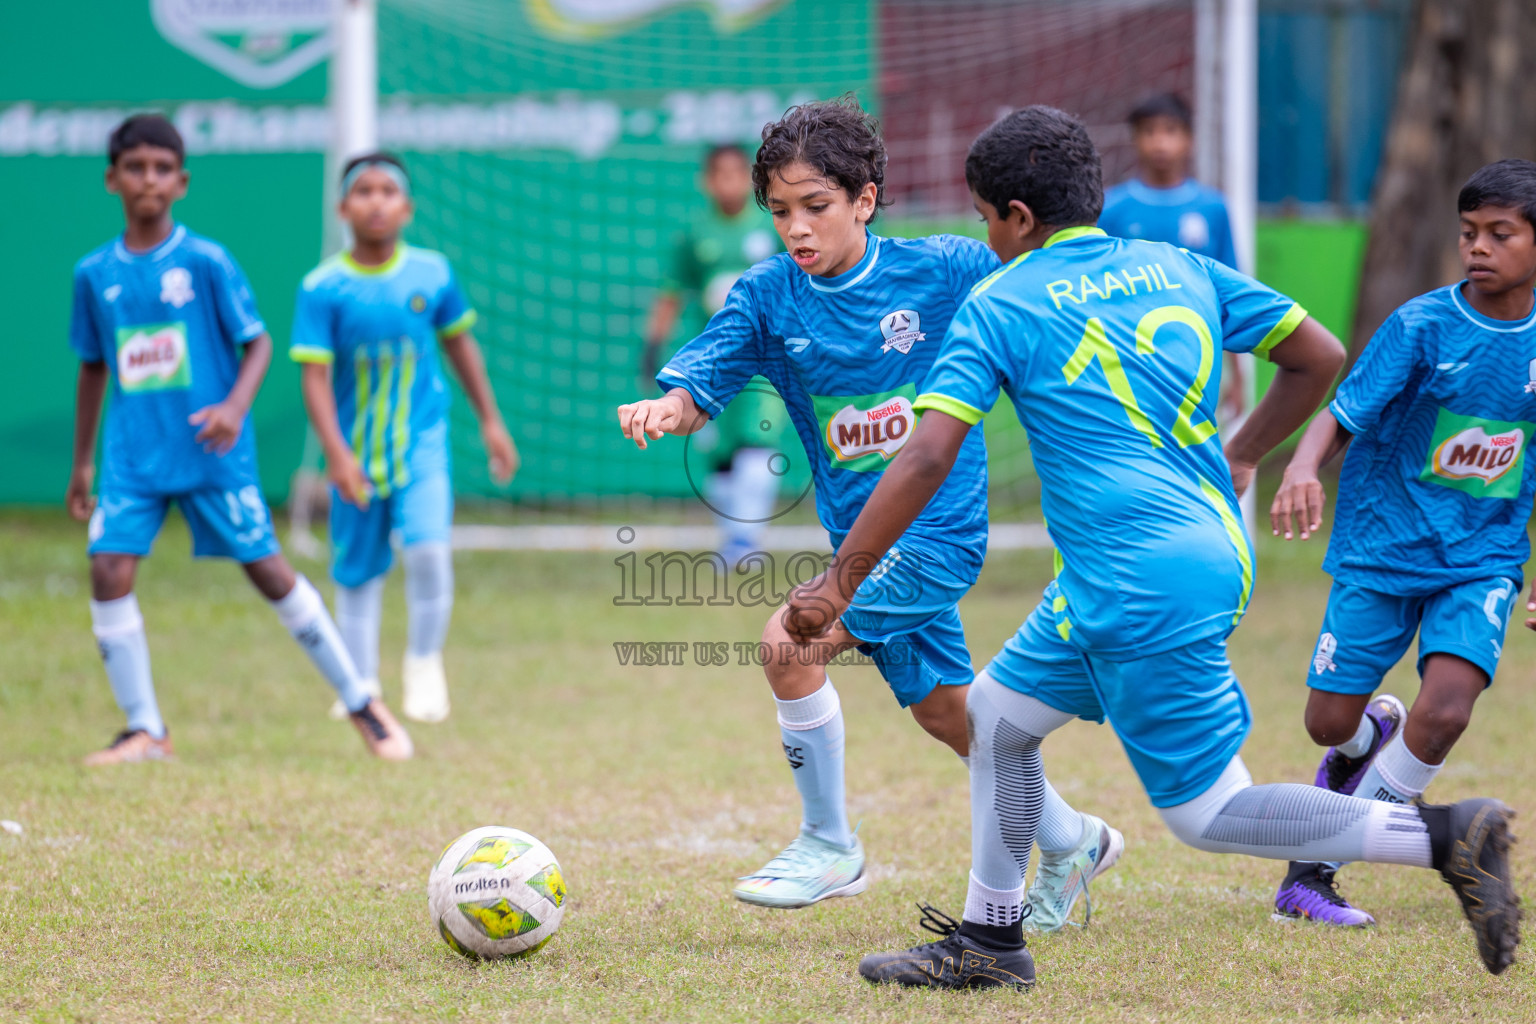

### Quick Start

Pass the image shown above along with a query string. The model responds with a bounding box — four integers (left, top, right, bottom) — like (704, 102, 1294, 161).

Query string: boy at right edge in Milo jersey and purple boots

(1272, 160, 1536, 926)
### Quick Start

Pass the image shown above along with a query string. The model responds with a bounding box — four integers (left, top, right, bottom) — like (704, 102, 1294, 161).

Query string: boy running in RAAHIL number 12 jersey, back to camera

(785, 107, 1519, 989)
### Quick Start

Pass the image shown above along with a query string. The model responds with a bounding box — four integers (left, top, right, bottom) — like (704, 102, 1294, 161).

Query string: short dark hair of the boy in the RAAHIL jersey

(965, 106, 1104, 227)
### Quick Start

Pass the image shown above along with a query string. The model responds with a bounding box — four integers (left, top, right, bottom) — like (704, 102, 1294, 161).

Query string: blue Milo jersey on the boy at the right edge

(1322, 284, 1536, 594)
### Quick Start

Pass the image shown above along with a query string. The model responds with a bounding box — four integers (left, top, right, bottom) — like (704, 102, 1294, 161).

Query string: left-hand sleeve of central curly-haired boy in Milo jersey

(656, 275, 766, 419)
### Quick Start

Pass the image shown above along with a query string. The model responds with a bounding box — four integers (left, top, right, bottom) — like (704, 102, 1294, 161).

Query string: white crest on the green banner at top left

(149, 0, 335, 89)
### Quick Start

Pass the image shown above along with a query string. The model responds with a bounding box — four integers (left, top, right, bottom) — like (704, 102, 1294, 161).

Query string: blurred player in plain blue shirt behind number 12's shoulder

(1098, 92, 1247, 421)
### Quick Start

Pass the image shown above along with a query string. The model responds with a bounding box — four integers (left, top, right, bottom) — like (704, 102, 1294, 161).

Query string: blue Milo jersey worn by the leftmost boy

(69, 224, 266, 494)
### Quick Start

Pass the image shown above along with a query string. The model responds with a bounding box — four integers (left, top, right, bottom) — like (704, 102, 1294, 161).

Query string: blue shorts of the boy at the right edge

(1307, 576, 1521, 694)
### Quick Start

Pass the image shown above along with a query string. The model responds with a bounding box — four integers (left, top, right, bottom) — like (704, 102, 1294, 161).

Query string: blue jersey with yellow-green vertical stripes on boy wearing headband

(289, 243, 475, 497)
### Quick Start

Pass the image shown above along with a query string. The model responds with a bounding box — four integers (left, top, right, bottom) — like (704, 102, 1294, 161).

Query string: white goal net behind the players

(295, 0, 1213, 552)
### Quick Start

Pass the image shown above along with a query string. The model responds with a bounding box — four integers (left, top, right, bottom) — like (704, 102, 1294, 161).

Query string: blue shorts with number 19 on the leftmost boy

(88, 484, 283, 565)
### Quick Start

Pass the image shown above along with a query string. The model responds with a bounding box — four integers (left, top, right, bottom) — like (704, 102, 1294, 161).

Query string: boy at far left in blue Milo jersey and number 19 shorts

(65, 115, 412, 765)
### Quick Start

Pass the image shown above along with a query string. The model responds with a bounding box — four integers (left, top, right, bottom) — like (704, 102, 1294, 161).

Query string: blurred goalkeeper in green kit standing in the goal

(641, 144, 788, 568)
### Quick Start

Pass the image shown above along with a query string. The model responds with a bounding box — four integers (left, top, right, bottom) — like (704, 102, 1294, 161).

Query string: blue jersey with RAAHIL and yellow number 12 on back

(917, 227, 1306, 660)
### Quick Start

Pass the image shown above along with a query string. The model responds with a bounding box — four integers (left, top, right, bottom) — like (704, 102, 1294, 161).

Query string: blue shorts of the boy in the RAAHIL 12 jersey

(986, 583, 1253, 808)
